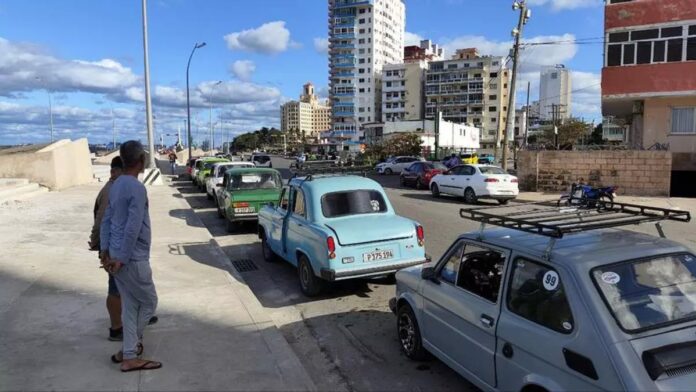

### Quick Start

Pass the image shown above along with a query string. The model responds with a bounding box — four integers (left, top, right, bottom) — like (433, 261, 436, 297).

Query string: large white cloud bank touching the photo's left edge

(0, 38, 140, 96)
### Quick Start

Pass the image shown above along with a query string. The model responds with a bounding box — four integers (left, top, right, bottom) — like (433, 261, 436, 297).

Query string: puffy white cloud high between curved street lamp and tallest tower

(224, 21, 296, 54)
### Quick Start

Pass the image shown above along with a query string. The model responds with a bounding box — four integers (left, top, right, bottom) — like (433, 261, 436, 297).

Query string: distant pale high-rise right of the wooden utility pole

(539, 64, 571, 120)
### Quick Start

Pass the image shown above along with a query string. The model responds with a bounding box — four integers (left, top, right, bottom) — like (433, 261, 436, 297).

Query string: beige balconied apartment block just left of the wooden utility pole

(425, 48, 512, 150)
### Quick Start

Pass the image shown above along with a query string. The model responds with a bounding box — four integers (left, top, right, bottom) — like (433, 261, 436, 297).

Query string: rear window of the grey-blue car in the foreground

(592, 254, 696, 331)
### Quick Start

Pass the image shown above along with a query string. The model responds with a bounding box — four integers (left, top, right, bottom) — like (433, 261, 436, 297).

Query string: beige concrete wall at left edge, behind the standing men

(0, 139, 93, 190)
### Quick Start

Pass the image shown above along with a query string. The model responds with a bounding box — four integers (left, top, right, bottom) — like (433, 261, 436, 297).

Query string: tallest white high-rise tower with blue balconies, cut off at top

(329, 0, 406, 140)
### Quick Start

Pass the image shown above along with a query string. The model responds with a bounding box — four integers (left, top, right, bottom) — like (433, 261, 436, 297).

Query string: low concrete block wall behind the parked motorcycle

(517, 151, 672, 196)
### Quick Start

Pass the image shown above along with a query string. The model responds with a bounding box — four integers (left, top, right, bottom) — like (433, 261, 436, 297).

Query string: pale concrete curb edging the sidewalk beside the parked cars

(166, 181, 317, 391)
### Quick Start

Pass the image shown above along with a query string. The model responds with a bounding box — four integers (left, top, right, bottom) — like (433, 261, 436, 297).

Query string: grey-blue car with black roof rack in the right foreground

(389, 202, 696, 391)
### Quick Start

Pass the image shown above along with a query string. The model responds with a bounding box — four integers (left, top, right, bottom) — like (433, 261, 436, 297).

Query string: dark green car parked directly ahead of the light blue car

(215, 168, 283, 233)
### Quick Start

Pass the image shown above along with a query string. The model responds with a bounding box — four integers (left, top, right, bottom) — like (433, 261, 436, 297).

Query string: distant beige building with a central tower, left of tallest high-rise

(280, 83, 331, 138)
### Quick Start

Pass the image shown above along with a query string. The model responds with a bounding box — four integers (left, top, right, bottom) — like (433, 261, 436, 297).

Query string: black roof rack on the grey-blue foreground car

(459, 201, 691, 239)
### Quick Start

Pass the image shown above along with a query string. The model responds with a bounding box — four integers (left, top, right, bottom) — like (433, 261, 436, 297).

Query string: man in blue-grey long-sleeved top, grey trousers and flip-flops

(100, 140, 162, 372)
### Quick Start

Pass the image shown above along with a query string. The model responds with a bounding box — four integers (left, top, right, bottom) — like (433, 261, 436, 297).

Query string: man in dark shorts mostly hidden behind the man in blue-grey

(89, 157, 123, 341)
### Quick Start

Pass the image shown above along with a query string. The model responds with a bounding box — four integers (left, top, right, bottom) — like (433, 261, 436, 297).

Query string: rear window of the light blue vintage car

(321, 189, 387, 218)
